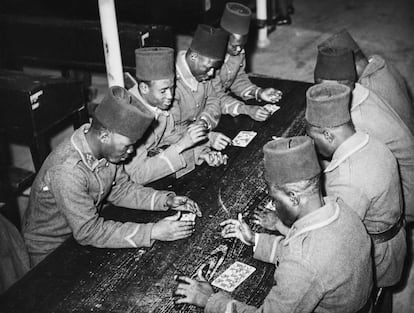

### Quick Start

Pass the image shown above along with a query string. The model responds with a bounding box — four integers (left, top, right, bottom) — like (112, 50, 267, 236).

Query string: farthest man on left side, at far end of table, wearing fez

(213, 2, 282, 121)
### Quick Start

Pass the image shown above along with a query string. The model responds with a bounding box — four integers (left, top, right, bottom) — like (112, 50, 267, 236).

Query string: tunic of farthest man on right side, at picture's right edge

(358, 55, 414, 134)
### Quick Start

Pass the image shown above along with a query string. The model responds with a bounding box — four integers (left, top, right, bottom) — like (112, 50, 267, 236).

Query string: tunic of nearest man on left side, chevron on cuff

(23, 124, 174, 266)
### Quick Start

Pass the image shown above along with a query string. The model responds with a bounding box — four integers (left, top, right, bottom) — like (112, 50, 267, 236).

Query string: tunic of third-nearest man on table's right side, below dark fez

(351, 83, 414, 221)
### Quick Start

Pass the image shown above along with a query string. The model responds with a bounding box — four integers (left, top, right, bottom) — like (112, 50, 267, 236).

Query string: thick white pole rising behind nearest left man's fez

(98, 0, 124, 87)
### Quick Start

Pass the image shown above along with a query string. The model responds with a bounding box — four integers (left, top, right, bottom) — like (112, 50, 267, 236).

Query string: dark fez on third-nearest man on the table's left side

(190, 24, 228, 60)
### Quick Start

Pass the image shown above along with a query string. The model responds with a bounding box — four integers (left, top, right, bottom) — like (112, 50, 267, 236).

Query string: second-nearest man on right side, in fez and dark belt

(306, 83, 406, 294)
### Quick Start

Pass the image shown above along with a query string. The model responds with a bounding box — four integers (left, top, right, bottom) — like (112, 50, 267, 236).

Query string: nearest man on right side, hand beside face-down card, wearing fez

(175, 136, 372, 313)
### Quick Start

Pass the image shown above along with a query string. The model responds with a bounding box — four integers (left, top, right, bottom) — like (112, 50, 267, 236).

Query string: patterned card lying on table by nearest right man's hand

(212, 261, 256, 292)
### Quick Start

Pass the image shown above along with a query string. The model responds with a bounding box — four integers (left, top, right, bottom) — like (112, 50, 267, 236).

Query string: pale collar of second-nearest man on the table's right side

(324, 132, 369, 173)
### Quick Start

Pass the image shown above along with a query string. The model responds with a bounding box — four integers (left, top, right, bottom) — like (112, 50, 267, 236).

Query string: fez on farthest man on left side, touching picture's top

(220, 2, 252, 35)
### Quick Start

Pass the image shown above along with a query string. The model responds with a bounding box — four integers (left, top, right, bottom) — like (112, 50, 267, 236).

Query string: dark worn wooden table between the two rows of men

(0, 76, 310, 313)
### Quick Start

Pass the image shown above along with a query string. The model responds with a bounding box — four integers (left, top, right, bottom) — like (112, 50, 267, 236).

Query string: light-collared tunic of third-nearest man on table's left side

(171, 51, 221, 131)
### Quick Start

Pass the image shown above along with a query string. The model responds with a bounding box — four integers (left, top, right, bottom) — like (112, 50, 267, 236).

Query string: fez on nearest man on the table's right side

(263, 136, 321, 185)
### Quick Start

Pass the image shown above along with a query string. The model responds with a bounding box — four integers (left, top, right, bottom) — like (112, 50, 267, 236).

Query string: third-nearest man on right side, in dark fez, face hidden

(314, 47, 414, 222)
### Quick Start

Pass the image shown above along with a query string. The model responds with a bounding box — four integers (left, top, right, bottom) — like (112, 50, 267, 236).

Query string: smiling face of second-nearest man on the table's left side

(145, 78, 175, 110)
